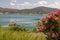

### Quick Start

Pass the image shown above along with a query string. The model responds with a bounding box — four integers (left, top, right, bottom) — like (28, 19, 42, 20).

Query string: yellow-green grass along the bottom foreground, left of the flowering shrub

(0, 29, 46, 40)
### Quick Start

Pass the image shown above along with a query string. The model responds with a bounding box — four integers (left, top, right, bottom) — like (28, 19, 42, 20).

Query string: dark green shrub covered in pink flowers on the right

(40, 10, 60, 40)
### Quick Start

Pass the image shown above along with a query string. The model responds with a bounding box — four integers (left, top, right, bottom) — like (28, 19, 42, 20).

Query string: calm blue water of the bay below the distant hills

(0, 14, 45, 28)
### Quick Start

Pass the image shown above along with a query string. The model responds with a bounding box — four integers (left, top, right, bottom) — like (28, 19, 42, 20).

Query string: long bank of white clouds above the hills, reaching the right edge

(10, 1, 60, 9)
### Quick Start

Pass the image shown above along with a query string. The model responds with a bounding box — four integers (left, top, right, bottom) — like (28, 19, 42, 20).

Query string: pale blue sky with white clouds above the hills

(0, 0, 60, 9)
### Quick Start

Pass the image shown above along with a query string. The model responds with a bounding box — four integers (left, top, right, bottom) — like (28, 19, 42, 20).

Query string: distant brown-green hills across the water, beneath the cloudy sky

(0, 6, 57, 14)
